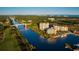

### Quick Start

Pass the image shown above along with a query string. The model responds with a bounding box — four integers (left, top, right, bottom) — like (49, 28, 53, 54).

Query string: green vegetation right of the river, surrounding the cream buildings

(16, 15, 79, 39)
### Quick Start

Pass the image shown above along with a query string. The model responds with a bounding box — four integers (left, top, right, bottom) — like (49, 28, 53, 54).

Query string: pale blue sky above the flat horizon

(0, 7, 79, 15)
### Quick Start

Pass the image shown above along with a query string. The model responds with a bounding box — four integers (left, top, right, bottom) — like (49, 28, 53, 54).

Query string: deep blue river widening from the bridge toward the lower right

(11, 18, 79, 51)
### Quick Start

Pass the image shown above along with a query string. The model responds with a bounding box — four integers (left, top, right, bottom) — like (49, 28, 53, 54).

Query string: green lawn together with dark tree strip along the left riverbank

(0, 27, 34, 51)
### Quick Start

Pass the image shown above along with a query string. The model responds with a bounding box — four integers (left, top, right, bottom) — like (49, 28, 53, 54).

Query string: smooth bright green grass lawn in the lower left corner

(0, 28, 21, 51)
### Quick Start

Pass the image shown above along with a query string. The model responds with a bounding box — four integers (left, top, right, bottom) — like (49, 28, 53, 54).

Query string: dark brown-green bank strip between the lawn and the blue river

(15, 28, 35, 51)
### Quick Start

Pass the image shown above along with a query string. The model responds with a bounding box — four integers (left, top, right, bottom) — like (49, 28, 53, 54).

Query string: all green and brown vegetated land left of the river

(0, 16, 35, 51)
